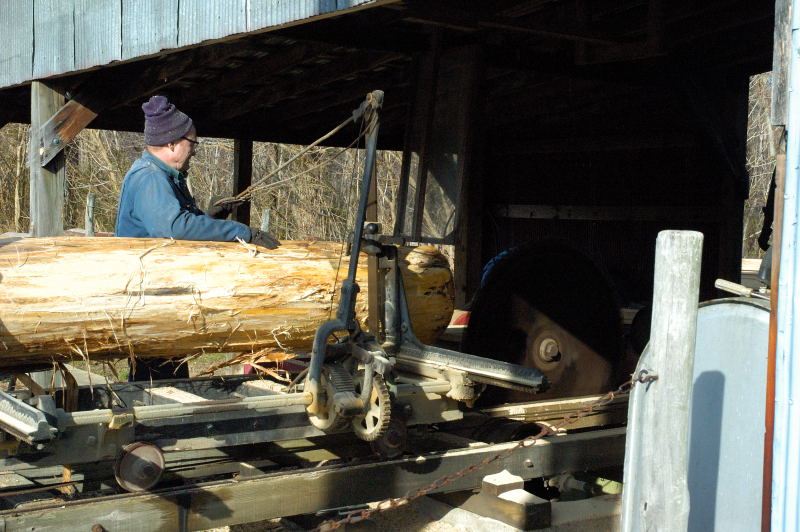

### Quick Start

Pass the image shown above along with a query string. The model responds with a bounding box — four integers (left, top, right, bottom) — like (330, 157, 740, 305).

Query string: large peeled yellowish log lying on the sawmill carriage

(0, 237, 453, 368)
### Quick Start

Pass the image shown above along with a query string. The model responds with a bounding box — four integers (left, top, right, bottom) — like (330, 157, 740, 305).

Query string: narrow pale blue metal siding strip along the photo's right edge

(772, 1, 800, 531)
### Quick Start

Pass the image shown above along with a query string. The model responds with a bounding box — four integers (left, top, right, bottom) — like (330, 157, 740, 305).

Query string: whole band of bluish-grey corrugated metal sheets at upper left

(0, 0, 384, 88)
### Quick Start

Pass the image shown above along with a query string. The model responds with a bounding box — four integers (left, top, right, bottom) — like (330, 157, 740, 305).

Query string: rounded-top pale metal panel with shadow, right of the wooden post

(688, 298, 769, 532)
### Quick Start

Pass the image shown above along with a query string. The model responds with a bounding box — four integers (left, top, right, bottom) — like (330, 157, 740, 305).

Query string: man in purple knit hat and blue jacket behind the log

(115, 96, 280, 380)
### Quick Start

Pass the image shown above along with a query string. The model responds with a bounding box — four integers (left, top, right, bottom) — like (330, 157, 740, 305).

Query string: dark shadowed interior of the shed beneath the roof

(0, 0, 775, 305)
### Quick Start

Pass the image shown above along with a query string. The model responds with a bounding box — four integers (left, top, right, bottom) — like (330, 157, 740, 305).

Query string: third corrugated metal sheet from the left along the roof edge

(74, 0, 122, 70)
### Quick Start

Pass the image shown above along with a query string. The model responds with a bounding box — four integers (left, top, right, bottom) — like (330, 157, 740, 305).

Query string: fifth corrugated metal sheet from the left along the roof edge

(178, 0, 247, 46)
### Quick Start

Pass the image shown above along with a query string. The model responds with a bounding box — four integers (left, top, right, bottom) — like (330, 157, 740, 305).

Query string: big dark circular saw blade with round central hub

(462, 242, 622, 404)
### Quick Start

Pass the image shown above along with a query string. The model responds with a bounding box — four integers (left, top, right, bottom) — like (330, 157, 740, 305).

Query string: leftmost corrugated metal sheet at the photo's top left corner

(0, 2, 33, 87)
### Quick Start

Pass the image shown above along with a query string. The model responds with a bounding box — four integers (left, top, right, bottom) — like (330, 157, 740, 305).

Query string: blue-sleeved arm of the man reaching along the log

(134, 174, 250, 242)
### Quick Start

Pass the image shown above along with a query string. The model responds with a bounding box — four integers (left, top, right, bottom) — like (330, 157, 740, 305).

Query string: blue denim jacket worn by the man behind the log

(116, 150, 250, 241)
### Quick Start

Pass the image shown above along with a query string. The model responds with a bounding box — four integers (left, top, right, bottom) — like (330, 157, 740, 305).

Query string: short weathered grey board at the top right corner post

(772, 0, 792, 126)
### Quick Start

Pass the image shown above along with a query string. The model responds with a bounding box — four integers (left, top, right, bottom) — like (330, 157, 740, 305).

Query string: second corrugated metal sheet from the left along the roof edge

(33, 0, 75, 78)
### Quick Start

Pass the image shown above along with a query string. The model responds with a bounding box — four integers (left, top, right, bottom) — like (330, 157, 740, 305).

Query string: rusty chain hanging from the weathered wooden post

(312, 369, 658, 532)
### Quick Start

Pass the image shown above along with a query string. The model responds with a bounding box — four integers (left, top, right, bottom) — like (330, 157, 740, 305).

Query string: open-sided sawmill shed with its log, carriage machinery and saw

(0, 0, 800, 531)
